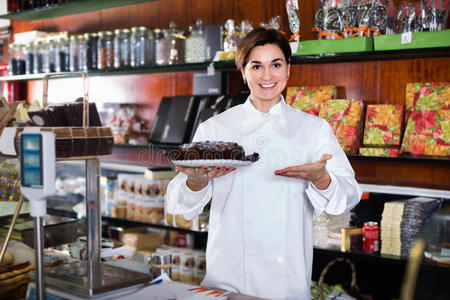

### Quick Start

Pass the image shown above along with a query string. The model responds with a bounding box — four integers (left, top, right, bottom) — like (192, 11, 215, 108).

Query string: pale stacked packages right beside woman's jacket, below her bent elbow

(314, 213, 350, 248)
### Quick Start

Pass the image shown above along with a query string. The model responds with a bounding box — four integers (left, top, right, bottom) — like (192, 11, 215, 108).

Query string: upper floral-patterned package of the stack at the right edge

(405, 82, 450, 120)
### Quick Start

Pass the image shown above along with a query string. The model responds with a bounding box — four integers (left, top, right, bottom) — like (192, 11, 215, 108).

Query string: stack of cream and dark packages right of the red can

(381, 197, 441, 256)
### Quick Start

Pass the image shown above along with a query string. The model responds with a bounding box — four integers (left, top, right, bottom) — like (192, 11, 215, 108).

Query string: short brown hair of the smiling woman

(235, 28, 292, 70)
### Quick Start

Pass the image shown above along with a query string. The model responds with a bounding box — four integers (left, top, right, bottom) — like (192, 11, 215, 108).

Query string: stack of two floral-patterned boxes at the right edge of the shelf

(401, 82, 450, 156)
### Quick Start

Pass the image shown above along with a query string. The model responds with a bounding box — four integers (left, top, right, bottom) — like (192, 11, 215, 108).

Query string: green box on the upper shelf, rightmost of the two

(373, 29, 450, 51)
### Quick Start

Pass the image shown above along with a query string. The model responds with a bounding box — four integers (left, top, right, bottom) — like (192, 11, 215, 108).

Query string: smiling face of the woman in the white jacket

(242, 44, 290, 105)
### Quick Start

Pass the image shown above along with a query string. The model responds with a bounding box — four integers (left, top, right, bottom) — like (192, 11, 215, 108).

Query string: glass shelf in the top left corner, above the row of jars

(0, 0, 155, 21)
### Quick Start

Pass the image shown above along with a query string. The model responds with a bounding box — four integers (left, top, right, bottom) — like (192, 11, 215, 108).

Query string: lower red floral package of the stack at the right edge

(401, 110, 450, 156)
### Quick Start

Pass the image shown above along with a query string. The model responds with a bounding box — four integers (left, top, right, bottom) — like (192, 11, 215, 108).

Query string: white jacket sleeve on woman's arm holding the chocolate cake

(166, 124, 213, 220)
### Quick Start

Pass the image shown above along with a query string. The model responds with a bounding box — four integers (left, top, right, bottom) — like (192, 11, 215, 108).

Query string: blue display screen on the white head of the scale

(20, 134, 42, 187)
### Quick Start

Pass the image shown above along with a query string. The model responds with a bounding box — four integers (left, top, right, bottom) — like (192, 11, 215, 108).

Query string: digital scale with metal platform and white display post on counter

(19, 127, 152, 300)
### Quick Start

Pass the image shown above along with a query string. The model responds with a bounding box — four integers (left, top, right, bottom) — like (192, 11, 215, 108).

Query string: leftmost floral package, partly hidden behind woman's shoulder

(286, 85, 337, 116)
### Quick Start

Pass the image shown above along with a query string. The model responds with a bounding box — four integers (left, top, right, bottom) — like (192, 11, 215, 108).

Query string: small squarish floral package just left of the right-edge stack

(363, 104, 403, 147)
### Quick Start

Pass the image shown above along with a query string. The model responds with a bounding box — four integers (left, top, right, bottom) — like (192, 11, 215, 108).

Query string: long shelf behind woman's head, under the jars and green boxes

(0, 47, 450, 81)
